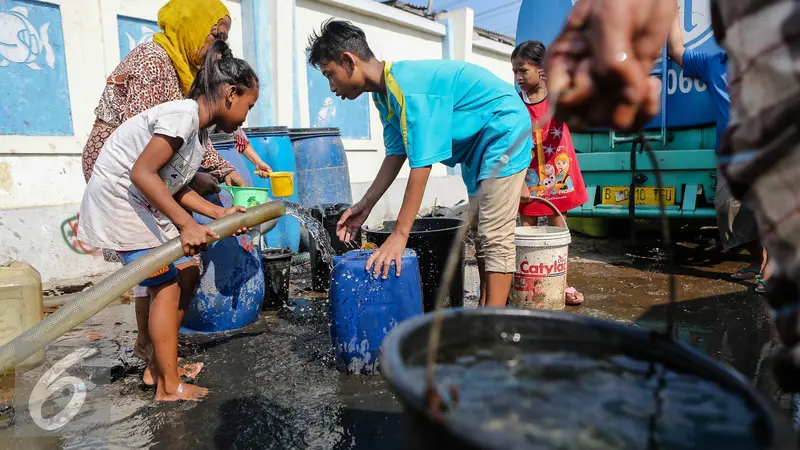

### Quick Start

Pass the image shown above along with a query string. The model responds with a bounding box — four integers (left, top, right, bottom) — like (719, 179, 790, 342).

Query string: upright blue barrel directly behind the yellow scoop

(244, 127, 300, 253)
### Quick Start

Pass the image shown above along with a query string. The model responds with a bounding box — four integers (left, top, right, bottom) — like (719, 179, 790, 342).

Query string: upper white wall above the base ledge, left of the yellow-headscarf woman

(0, 0, 242, 210)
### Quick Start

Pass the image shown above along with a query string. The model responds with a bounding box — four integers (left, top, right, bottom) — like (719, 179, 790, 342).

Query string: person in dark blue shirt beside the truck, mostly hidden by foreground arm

(667, 10, 769, 293)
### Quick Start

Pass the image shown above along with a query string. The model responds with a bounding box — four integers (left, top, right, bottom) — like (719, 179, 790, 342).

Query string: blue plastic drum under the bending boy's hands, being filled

(329, 250, 422, 375)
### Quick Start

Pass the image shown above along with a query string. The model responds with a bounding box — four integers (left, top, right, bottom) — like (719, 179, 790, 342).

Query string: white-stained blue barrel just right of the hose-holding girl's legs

(181, 191, 264, 333)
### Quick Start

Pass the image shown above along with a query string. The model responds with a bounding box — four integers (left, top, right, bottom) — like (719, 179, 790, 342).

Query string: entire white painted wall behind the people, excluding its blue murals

(0, 0, 512, 281)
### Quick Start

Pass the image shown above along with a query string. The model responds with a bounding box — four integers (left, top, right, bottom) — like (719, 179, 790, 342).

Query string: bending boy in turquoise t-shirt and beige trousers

(308, 20, 533, 307)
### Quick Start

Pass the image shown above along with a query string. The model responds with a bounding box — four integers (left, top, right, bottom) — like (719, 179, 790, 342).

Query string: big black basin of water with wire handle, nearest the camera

(381, 308, 796, 450)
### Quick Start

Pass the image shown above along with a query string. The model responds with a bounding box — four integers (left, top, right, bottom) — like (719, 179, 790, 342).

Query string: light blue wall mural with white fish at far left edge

(0, 0, 74, 136)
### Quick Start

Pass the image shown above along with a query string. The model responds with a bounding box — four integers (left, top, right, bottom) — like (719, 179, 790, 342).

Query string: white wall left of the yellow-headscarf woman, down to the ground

(0, 0, 242, 282)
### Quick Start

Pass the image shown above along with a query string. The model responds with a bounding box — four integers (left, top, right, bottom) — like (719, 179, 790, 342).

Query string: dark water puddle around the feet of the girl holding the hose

(0, 299, 404, 449)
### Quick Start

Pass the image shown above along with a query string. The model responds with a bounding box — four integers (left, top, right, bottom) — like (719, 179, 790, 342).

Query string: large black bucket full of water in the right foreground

(381, 308, 795, 450)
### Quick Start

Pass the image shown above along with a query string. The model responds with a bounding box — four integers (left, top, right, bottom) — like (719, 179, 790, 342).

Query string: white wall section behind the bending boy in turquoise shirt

(295, 0, 513, 217)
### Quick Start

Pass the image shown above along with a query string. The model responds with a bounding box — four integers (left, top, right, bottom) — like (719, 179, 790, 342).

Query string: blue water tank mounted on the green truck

(517, 0, 722, 128)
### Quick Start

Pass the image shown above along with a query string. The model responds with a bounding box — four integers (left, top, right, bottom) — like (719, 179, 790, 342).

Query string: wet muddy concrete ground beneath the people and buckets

(0, 223, 785, 450)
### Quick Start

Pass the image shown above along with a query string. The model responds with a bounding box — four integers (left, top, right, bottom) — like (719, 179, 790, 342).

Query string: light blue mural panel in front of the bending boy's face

(307, 57, 370, 139)
